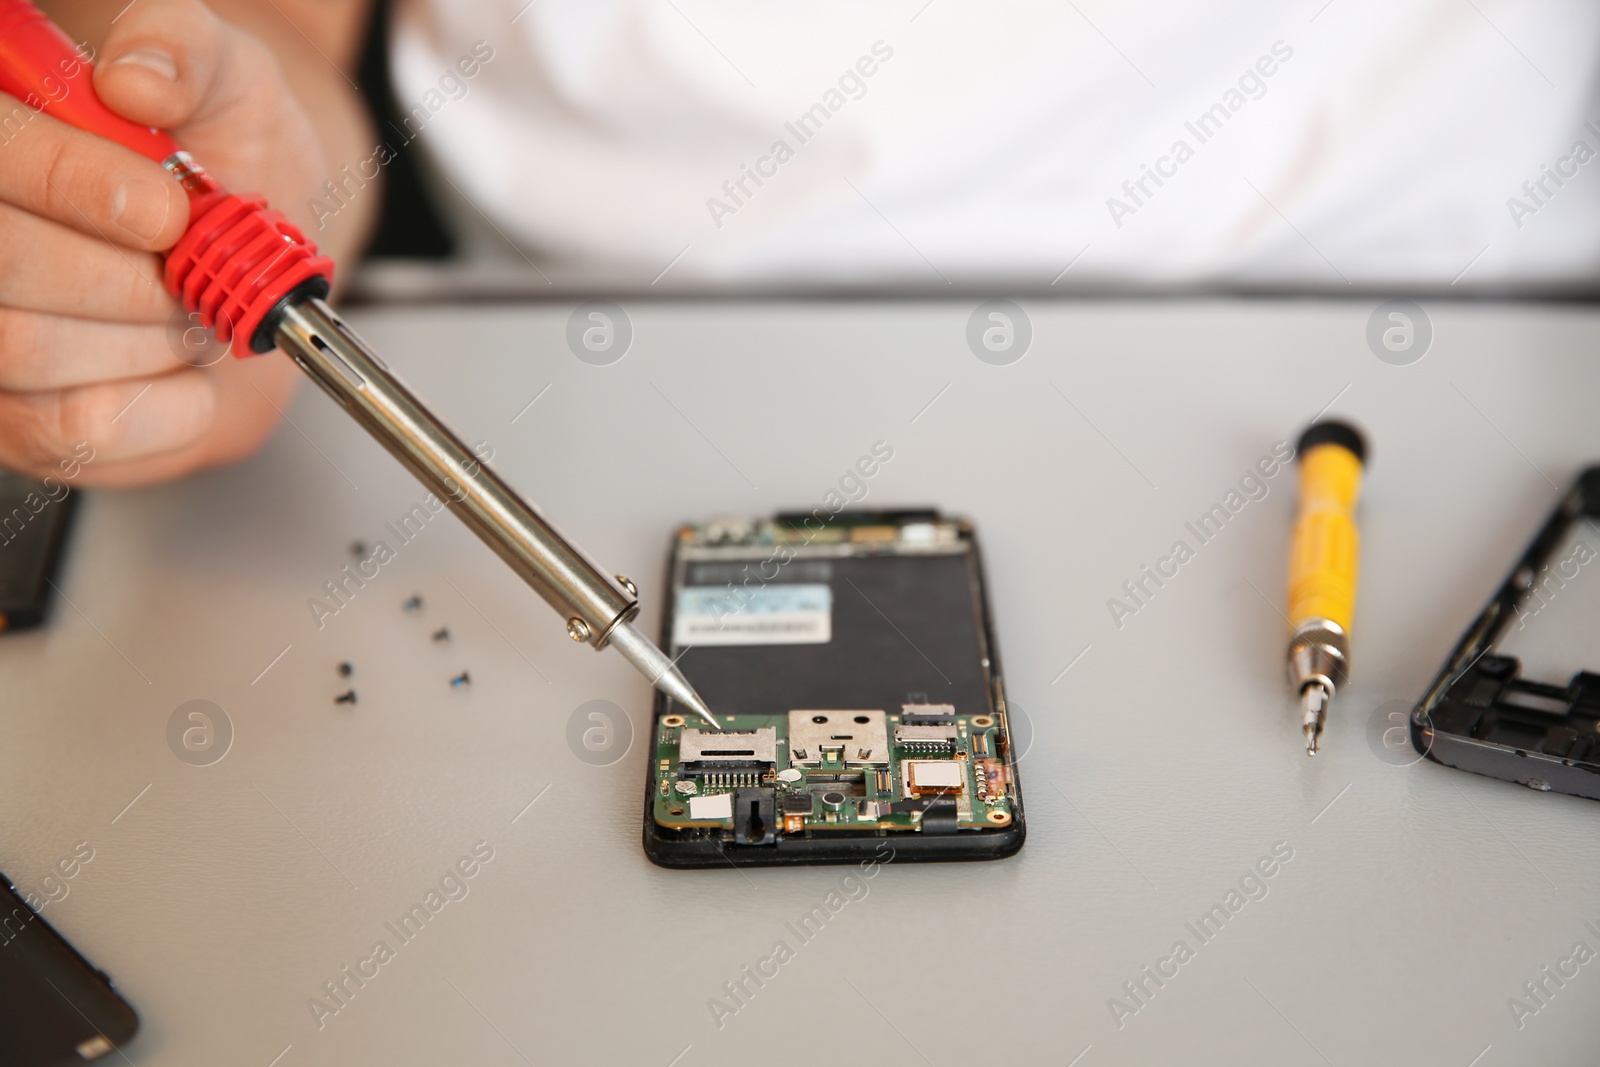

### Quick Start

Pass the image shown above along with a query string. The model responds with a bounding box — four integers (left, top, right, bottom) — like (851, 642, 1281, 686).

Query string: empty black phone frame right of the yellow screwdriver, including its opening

(1411, 467, 1600, 800)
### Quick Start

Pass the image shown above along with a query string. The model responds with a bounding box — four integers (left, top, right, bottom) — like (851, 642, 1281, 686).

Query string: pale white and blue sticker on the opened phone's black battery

(672, 582, 834, 646)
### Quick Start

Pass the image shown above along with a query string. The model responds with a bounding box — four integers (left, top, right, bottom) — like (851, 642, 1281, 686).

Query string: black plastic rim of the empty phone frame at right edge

(1411, 467, 1600, 800)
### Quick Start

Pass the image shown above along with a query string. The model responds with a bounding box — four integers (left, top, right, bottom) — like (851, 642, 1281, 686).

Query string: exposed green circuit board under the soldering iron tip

(653, 704, 1014, 845)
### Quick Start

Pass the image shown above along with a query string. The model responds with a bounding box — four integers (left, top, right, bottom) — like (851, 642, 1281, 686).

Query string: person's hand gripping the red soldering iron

(0, 0, 345, 486)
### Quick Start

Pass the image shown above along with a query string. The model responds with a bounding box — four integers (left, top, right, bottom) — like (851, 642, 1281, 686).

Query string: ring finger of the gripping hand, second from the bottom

(0, 307, 212, 392)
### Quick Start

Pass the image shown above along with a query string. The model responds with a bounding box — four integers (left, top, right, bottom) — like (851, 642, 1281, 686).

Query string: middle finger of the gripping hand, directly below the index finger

(0, 203, 176, 323)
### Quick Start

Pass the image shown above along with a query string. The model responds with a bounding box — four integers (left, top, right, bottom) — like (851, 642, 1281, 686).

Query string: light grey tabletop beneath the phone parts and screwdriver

(0, 301, 1600, 1067)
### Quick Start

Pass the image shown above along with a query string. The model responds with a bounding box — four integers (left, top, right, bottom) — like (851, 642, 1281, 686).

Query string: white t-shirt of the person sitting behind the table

(386, 0, 1600, 291)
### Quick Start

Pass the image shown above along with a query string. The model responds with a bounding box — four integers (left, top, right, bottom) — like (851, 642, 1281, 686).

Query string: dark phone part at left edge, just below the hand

(0, 470, 78, 633)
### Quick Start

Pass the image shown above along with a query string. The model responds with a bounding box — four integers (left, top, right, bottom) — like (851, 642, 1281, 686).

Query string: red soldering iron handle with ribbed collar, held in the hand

(0, 0, 333, 355)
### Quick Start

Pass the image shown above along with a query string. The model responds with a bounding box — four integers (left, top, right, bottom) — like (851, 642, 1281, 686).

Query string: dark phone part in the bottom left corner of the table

(0, 875, 139, 1067)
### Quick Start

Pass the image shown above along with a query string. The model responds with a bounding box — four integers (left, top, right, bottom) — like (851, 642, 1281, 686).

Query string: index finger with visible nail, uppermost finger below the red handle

(0, 93, 189, 250)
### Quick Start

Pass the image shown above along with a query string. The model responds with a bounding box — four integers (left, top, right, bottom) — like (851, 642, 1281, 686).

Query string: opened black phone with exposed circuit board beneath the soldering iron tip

(645, 509, 1024, 867)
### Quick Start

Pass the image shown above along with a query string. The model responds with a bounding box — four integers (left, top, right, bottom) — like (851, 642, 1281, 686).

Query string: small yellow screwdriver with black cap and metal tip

(1288, 421, 1366, 755)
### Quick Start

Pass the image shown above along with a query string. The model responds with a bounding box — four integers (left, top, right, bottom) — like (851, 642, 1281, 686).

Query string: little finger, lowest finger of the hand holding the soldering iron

(0, 368, 216, 472)
